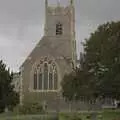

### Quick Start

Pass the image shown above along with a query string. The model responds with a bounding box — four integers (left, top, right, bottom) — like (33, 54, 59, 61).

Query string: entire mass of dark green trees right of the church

(62, 22, 120, 105)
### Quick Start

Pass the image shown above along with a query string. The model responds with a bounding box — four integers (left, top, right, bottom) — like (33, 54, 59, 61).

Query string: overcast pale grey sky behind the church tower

(0, 0, 120, 71)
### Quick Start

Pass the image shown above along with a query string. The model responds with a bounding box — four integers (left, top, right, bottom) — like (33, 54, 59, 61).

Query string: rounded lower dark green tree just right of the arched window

(62, 68, 95, 101)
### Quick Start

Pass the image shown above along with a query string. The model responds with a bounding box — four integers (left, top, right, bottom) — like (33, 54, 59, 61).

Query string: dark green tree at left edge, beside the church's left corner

(0, 60, 19, 112)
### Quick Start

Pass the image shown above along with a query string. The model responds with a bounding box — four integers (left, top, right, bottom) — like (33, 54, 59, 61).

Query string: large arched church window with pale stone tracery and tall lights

(33, 59, 58, 91)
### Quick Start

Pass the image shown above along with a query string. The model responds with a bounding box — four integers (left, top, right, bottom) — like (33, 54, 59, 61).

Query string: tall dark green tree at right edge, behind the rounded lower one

(84, 22, 120, 99)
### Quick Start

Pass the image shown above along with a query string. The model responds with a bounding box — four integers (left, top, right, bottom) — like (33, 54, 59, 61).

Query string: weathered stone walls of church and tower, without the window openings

(20, 0, 76, 110)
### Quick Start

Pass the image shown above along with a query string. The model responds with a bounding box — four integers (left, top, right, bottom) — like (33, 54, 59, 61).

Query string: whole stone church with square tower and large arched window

(20, 0, 77, 110)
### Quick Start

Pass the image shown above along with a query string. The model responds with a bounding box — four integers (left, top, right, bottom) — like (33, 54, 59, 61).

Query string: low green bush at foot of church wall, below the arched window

(18, 103, 45, 114)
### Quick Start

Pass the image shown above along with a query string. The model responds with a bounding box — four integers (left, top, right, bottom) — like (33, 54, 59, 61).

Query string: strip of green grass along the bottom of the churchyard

(0, 110, 120, 120)
